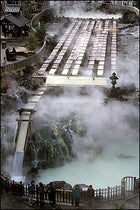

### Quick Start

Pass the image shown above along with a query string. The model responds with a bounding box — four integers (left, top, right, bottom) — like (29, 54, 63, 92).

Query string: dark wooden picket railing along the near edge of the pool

(0, 175, 139, 204)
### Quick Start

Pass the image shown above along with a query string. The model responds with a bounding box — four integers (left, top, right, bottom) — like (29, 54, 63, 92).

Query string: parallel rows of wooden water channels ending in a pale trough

(33, 19, 117, 86)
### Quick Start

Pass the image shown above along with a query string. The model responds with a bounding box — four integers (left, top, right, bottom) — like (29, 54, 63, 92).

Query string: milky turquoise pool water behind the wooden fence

(35, 139, 139, 189)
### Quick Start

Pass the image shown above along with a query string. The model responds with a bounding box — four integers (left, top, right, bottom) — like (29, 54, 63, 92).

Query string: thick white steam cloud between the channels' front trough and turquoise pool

(35, 88, 138, 147)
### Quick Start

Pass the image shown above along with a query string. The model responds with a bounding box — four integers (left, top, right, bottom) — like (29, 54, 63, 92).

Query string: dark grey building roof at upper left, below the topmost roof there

(4, 14, 30, 27)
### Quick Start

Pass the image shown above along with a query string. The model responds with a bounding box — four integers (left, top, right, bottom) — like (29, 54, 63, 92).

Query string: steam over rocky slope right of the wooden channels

(117, 26, 139, 88)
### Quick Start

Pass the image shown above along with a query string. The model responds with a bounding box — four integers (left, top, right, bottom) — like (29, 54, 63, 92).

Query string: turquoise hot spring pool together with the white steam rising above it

(23, 87, 139, 189)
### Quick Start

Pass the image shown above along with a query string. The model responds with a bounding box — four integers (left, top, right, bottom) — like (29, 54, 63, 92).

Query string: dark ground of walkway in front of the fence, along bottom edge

(1, 190, 139, 210)
